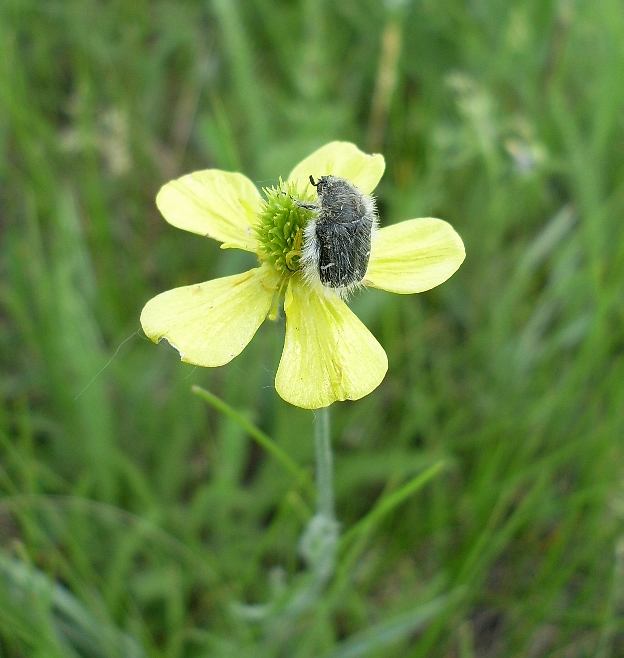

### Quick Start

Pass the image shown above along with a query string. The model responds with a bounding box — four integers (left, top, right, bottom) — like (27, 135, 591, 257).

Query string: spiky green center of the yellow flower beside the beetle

(255, 178, 314, 275)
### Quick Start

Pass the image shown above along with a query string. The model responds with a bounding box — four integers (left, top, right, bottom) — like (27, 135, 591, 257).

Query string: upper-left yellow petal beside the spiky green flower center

(156, 169, 260, 251)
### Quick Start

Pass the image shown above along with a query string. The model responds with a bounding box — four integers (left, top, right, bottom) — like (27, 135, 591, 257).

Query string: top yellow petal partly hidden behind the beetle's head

(288, 142, 386, 194)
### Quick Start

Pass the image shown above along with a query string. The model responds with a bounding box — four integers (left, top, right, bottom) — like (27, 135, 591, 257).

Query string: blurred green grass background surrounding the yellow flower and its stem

(0, 0, 624, 658)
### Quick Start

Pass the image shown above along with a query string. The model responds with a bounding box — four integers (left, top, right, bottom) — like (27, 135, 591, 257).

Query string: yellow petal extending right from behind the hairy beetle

(363, 217, 466, 293)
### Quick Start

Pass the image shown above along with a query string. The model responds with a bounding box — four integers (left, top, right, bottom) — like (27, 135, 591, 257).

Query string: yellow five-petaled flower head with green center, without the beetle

(141, 142, 465, 409)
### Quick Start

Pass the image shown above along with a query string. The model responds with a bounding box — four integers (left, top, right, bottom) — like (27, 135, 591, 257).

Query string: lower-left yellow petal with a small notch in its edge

(141, 267, 277, 367)
